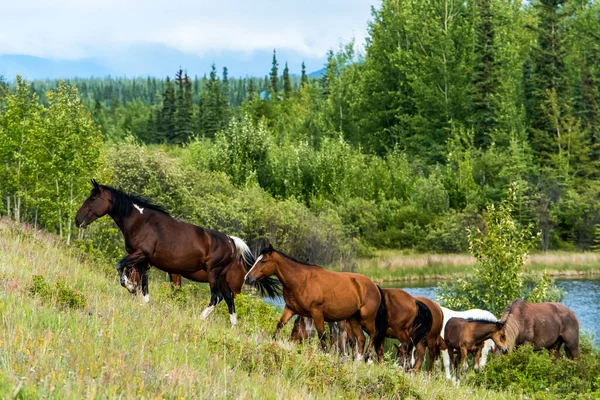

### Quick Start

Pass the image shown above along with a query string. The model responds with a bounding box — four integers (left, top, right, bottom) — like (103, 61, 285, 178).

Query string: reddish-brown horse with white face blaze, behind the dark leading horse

(245, 245, 387, 362)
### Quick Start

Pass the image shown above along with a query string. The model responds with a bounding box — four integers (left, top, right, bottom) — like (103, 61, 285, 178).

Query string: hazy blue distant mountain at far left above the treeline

(0, 54, 110, 79)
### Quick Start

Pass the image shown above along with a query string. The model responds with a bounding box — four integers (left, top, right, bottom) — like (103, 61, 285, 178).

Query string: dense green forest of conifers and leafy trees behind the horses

(0, 0, 600, 262)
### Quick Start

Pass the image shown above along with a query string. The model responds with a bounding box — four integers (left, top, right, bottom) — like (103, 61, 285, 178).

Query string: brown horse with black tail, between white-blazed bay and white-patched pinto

(376, 289, 433, 367)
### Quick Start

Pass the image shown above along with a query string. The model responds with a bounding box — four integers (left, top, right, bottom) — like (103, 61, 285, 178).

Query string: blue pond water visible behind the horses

(269, 279, 600, 345)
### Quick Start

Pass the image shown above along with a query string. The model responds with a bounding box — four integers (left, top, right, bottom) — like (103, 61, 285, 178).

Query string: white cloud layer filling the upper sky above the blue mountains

(0, 0, 375, 60)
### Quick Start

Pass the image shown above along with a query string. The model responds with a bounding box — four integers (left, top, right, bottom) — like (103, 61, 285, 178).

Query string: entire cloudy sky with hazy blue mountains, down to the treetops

(0, 0, 379, 77)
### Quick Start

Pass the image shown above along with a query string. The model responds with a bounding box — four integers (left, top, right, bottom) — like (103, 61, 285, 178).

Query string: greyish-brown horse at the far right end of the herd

(502, 299, 579, 359)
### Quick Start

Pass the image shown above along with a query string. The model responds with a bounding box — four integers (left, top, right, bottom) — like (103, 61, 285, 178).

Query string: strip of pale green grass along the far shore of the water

(356, 250, 600, 282)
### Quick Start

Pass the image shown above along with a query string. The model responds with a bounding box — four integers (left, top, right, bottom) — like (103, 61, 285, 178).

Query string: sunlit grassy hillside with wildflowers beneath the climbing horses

(0, 219, 507, 399)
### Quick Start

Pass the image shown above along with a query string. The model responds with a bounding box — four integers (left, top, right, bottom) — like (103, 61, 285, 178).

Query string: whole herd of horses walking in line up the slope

(75, 180, 579, 378)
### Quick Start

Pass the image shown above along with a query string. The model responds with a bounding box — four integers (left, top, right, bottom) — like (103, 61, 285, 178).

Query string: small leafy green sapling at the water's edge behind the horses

(438, 188, 562, 315)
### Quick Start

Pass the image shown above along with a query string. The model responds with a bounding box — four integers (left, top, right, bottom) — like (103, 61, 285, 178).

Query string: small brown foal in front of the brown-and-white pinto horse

(444, 317, 508, 380)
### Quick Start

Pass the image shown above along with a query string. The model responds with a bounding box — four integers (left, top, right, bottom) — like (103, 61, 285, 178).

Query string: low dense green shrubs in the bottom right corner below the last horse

(468, 339, 600, 399)
